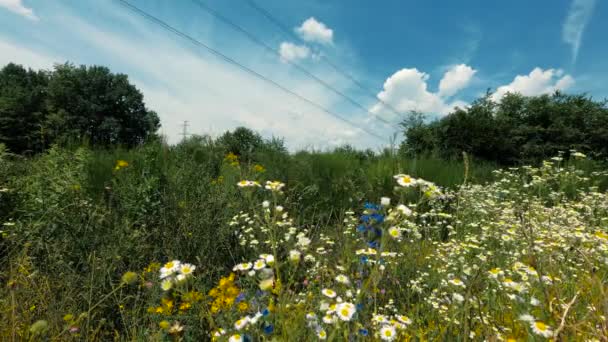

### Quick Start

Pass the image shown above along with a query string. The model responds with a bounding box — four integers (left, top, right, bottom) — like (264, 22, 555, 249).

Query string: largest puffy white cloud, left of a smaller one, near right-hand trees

(371, 68, 466, 119)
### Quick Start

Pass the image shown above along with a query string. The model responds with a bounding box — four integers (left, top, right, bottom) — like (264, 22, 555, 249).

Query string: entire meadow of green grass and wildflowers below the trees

(0, 138, 608, 342)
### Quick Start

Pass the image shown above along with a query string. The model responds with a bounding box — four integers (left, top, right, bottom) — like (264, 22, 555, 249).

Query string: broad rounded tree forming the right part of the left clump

(46, 64, 160, 147)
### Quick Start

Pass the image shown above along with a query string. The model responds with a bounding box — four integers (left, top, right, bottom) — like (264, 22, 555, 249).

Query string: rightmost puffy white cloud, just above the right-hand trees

(492, 67, 574, 101)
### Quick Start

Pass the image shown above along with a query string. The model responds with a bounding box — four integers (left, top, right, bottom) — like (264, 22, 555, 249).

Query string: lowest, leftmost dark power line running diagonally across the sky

(118, 0, 385, 140)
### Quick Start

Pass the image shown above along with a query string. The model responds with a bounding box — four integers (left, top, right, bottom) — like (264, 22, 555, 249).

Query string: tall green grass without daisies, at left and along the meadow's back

(0, 139, 605, 340)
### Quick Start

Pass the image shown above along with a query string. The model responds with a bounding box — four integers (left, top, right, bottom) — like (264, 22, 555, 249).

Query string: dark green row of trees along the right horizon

(401, 92, 608, 165)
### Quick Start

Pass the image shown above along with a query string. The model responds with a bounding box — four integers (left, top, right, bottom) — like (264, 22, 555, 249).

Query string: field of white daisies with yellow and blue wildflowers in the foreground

(0, 144, 608, 342)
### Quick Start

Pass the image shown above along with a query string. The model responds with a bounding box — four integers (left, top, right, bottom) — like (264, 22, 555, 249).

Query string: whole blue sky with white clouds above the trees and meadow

(0, 0, 608, 149)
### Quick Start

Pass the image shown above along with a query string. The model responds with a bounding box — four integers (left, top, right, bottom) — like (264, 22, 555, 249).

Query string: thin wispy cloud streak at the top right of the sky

(562, 0, 596, 61)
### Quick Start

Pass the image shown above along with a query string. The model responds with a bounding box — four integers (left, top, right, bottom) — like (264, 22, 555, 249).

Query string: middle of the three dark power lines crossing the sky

(192, 0, 392, 126)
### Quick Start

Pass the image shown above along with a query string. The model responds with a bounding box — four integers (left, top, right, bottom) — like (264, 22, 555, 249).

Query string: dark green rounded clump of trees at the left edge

(0, 63, 159, 154)
